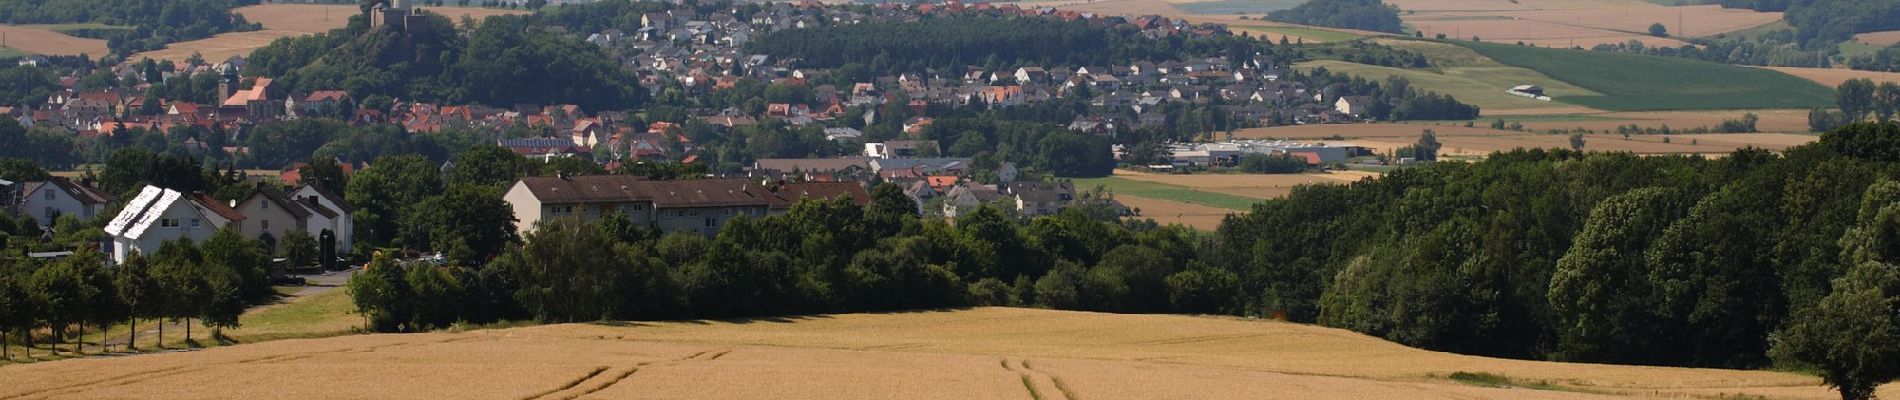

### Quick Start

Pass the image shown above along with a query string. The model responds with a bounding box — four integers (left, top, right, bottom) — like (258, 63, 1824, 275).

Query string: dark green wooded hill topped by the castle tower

(245, 9, 646, 110)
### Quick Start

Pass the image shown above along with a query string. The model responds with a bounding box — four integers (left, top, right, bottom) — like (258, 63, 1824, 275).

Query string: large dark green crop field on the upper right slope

(1457, 42, 1834, 110)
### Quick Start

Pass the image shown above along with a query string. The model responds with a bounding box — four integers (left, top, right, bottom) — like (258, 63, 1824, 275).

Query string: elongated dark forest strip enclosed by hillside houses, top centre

(745, 15, 1292, 74)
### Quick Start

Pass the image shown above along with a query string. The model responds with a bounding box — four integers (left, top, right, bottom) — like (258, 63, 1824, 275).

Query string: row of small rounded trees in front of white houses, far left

(0, 229, 276, 360)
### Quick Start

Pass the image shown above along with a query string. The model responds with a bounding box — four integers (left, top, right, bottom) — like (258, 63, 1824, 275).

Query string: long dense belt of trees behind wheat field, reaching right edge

(350, 123, 1900, 400)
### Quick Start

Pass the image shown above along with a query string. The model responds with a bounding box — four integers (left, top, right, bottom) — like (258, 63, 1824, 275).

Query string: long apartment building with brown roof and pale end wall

(504, 174, 870, 235)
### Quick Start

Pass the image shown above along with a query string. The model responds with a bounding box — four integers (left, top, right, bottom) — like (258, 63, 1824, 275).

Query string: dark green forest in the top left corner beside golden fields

(0, 0, 258, 59)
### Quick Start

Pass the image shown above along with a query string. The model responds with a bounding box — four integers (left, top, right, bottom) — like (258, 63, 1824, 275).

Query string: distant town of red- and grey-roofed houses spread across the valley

(0, 2, 1398, 161)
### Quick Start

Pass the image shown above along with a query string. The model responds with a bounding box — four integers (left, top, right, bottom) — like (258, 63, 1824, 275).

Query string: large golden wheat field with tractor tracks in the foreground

(0, 307, 1884, 400)
